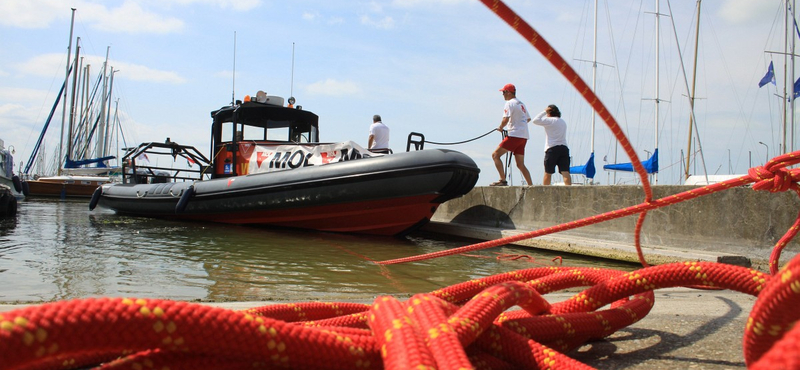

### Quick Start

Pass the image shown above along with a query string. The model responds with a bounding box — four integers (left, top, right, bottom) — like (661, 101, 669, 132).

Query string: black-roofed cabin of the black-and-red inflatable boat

(210, 91, 319, 178)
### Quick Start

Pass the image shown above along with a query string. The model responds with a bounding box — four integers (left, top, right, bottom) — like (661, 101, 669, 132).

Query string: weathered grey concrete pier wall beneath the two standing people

(432, 185, 800, 266)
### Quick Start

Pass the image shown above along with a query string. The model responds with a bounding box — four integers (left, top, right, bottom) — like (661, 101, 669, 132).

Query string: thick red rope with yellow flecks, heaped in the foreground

(0, 257, 788, 369)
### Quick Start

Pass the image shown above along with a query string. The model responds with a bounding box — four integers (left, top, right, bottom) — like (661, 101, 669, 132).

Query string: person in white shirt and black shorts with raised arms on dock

(533, 104, 572, 185)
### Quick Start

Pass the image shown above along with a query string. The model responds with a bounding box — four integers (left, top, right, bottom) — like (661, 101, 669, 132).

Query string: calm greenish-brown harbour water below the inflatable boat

(0, 199, 635, 303)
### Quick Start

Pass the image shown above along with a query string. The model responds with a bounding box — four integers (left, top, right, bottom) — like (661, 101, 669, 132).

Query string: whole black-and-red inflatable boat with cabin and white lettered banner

(89, 92, 480, 235)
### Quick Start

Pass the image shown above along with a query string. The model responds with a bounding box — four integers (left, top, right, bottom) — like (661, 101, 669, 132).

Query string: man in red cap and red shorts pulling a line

(489, 84, 532, 186)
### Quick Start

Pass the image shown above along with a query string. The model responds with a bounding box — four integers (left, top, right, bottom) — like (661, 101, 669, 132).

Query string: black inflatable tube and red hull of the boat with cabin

(97, 149, 479, 235)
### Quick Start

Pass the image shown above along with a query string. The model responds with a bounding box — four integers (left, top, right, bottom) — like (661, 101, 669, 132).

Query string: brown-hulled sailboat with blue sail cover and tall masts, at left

(23, 9, 118, 199)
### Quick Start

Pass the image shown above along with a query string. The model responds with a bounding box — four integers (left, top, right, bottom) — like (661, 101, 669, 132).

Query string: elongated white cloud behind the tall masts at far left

(16, 54, 186, 84)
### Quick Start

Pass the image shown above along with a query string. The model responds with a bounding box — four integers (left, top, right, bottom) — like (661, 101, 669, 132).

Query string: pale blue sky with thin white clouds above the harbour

(0, 0, 800, 185)
